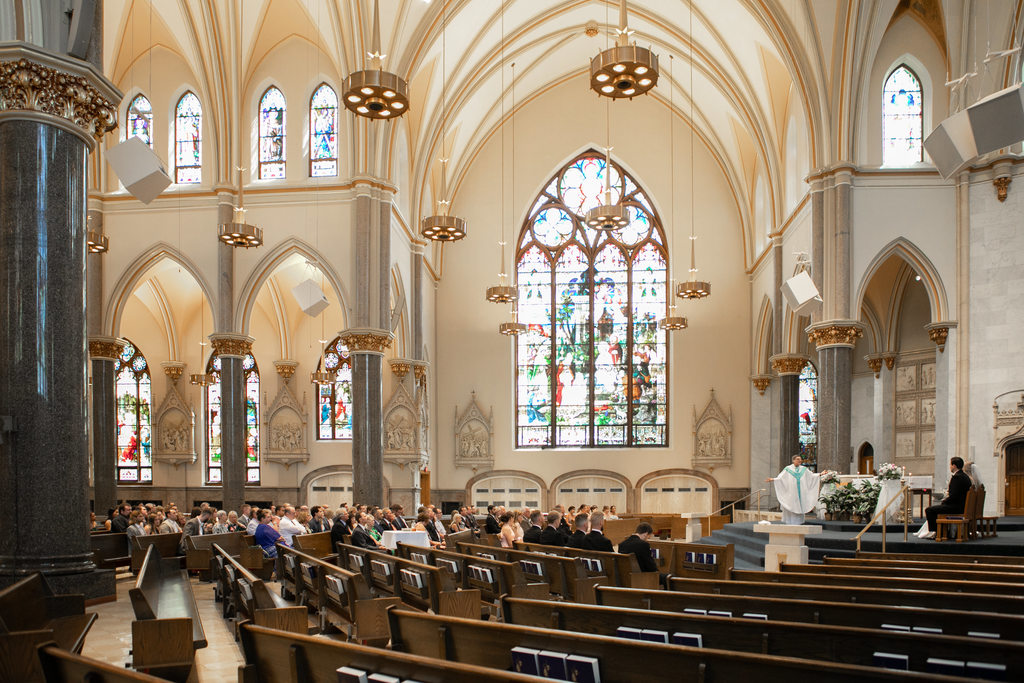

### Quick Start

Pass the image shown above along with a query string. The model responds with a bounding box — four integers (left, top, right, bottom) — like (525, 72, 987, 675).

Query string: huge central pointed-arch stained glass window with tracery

(516, 152, 668, 447)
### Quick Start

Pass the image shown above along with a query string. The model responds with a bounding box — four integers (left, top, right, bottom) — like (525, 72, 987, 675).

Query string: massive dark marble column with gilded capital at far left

(0, 43, 121, 598)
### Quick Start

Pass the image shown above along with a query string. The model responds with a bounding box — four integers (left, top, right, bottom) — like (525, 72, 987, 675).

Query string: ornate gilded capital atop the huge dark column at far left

(0, 42, 122, 150)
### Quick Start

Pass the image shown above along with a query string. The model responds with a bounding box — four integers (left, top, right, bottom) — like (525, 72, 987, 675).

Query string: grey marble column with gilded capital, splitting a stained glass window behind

(210, 334, 253, 510)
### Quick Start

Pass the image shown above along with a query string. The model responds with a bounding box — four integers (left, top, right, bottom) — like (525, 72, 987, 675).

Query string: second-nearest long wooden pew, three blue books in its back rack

(388, 608, 967, 683)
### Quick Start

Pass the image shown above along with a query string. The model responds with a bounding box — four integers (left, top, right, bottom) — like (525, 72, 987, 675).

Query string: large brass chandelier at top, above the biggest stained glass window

(590, 0, 658, 99)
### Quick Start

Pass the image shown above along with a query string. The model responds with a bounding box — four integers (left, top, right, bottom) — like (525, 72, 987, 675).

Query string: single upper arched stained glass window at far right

(882, 65, 924, 166)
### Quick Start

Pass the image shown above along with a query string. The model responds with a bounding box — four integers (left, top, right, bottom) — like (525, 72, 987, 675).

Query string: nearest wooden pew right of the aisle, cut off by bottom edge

(239, 624, 543, 683)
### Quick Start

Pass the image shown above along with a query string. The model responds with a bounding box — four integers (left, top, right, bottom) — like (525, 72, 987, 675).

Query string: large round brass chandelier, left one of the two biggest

(341, 0, 409, 120)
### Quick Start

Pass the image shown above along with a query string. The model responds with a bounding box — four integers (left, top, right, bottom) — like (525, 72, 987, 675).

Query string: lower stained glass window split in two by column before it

(206, 353, 259, 484)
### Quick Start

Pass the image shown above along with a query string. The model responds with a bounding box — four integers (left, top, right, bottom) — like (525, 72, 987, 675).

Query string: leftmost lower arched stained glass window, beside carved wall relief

(114, 342, 153, 483)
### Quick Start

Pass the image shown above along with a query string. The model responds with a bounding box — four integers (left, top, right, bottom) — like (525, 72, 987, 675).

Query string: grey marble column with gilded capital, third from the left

(339, 328, 394, 505)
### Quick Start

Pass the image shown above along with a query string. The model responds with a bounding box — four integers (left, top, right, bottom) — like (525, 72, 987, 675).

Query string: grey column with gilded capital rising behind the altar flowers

(807, 321, 863, 473)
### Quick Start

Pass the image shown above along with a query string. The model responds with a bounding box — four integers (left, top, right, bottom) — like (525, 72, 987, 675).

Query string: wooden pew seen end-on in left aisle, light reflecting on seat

(128, 546, 207, 681)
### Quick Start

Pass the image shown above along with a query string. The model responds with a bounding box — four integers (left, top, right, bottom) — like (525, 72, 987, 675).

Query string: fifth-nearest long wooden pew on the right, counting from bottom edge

(669, 572, 1024, 614)
